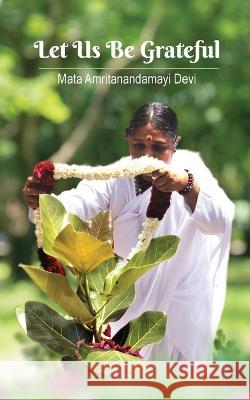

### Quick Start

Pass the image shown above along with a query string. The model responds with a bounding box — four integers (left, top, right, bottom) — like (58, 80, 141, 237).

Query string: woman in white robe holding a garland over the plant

(24, 103, 234, 360)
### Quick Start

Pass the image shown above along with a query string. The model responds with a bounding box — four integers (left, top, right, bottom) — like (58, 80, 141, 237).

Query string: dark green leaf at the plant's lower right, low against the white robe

(125, 311, 167, 350)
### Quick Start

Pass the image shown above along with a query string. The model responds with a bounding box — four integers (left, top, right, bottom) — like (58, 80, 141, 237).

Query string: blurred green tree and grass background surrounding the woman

(0, 0, 250, 360)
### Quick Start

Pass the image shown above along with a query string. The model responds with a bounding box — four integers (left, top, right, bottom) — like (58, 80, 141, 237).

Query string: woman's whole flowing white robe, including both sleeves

(54, 150, 234, 360)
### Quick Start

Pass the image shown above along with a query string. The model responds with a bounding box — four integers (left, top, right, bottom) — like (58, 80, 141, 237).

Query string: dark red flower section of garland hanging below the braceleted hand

(147, 185, 172, 221)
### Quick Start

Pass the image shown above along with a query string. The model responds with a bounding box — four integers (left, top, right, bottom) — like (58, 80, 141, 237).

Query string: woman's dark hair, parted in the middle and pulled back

(125, 103, 178, 143)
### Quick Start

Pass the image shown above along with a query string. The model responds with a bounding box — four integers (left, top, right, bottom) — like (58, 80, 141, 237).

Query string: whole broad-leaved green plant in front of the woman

(17, 195, 179, 361)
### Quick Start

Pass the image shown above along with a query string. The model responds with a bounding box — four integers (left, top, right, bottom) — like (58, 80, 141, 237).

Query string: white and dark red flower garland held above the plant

(33, 156, 171, 274)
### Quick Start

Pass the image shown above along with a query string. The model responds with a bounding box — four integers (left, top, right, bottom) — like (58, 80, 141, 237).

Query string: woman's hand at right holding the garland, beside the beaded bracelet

(152, 169, 188, 192)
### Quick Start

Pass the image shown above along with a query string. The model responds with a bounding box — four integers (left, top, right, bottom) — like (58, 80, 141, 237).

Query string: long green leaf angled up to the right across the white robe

(104, 235, 180, 296)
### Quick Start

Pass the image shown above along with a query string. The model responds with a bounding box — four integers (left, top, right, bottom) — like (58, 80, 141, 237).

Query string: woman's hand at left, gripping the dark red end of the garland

(23, 176, 53, 210)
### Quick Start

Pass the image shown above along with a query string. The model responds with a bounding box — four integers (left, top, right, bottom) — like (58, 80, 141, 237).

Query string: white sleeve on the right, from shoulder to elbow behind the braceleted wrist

(184, 153, 234, 235)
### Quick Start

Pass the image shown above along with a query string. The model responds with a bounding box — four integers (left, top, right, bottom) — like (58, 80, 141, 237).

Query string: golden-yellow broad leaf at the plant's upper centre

(53, 225, 114, 273)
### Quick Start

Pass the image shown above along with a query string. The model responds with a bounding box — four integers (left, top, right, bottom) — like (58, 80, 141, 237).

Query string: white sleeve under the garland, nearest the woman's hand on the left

(54, 180, 110, 220)
